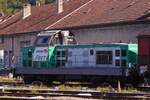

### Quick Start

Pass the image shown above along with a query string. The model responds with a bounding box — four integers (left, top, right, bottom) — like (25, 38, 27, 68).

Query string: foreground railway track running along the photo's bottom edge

(0, 89, 150, 100)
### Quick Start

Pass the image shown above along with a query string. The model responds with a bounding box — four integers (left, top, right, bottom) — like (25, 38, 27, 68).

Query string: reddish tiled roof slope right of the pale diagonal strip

(49, 0, 150, 28)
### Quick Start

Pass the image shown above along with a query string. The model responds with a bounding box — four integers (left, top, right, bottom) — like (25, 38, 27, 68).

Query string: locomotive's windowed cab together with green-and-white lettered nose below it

(21, 30, 76, 68)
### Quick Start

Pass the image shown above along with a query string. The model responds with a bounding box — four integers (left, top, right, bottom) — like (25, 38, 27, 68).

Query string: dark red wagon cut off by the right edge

(138, 35, 150, 79)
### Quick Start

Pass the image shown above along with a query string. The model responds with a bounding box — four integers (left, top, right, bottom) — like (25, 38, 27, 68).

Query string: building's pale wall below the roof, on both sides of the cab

(0, 22, 150, 66)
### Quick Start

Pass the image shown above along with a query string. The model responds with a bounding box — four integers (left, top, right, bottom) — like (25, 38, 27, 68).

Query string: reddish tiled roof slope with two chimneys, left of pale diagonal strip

(0, 0, 89, 34)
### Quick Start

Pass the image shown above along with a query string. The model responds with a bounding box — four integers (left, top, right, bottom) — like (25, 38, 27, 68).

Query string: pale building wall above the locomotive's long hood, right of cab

(71, 24, 150, 43)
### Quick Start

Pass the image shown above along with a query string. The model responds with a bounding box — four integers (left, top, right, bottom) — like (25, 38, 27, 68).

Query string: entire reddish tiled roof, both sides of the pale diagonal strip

(0, 0, 150, 34)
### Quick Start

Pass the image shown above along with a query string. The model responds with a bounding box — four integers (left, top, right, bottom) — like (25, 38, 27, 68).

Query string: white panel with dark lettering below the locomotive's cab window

(33, 47, 48, 61)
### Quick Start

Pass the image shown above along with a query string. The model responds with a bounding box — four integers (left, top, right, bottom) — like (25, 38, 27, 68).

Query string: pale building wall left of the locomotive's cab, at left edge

(0, 33, 36, 67)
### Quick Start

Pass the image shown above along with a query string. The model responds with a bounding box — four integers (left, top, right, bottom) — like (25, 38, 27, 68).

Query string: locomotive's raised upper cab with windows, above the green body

(34, 31, 76, 47)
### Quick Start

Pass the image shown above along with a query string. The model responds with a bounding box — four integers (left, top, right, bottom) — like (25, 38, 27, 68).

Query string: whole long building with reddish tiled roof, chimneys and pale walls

(0, 0, 150, 66)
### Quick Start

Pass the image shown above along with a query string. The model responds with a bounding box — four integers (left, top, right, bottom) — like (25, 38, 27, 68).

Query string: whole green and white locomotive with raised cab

(15, 31, 137, 82)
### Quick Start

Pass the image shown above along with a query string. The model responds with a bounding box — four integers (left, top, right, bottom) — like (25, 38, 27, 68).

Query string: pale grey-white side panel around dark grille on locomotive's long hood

(65, 47, 120, 67)
